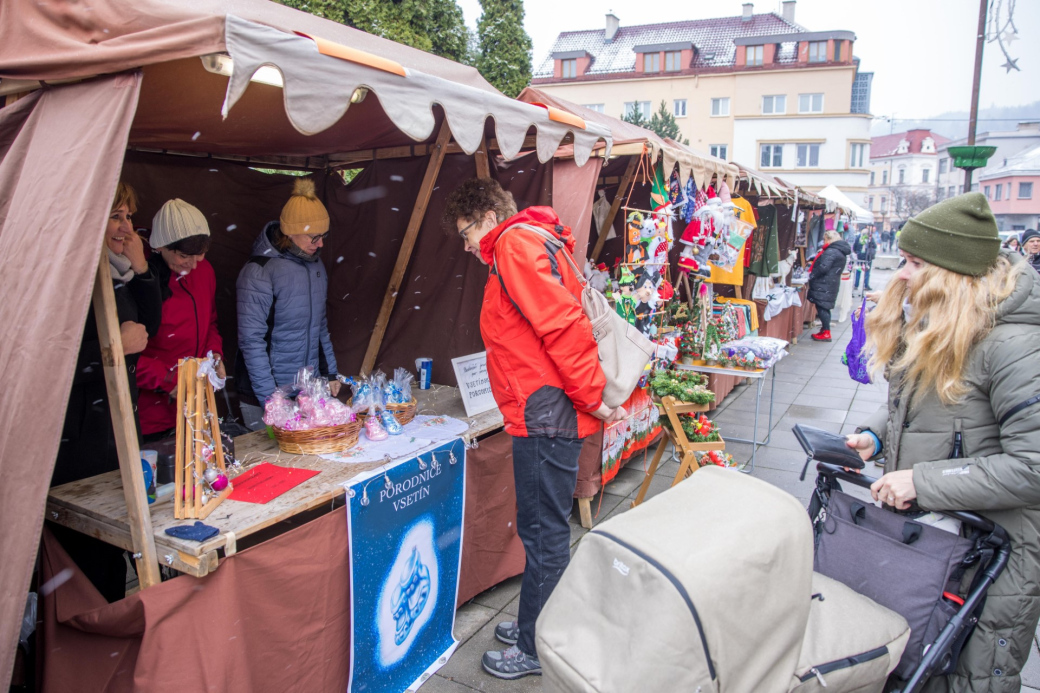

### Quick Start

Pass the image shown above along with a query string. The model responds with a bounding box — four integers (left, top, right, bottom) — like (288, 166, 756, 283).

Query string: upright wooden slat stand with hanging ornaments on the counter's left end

(174, 359, 234, 519)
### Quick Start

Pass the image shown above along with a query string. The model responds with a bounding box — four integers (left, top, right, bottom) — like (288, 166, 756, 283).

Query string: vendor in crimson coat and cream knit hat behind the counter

(137, 199, 225, 440)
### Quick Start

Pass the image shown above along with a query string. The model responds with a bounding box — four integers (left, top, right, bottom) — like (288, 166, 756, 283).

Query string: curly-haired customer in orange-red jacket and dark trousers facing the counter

(444, 178, 626, 678)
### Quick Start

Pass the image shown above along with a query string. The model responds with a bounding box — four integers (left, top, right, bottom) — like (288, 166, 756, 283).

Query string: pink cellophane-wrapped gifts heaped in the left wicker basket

(263, 366, 357, 431)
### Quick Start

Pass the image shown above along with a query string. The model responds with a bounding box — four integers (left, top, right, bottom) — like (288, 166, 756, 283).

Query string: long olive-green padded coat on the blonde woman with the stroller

(860, 250, 1040, 693)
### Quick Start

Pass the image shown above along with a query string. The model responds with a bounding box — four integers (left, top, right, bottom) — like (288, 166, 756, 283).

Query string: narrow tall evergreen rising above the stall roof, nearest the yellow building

(476, 0, 531, 97)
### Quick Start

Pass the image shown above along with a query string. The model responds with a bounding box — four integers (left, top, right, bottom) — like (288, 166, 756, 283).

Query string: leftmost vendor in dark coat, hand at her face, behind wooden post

(51, 183, 162, 601)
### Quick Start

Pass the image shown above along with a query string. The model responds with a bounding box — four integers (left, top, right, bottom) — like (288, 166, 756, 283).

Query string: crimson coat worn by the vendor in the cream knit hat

(137, 253, 224, 435)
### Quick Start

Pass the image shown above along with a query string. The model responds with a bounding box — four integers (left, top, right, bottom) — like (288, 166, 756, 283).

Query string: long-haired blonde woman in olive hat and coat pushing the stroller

(849, 193, 1040, 693)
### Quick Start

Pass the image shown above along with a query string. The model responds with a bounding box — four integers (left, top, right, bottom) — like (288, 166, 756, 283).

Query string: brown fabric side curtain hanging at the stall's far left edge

(0, 74, 140, 682)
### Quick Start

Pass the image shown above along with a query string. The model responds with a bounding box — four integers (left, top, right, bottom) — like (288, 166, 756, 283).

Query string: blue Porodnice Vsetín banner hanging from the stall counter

(346, 438, 466, 693)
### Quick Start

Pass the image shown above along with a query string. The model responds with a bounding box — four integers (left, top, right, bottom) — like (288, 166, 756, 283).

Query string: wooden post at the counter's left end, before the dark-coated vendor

(94, 249, 160, 589)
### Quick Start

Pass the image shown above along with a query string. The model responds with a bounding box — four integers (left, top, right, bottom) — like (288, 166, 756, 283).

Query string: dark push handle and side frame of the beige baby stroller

(803, 462, 1011, 693)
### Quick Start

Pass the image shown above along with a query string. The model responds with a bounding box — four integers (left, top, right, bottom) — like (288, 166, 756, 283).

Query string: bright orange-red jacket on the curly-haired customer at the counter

(480, 207, 606, 438)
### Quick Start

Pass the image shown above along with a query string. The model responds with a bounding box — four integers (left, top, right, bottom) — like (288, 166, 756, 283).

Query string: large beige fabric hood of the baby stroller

(537, 466, 813, 693)
